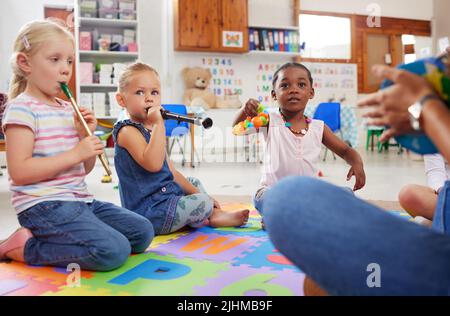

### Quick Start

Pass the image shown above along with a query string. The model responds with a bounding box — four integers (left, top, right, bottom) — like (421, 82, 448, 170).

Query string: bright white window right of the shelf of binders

(300, 14, 352, 59)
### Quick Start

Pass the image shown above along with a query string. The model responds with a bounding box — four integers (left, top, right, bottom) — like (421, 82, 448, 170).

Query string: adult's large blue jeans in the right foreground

(264, 177, 450, 295)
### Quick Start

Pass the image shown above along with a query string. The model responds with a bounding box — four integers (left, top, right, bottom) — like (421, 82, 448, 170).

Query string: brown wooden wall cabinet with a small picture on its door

(174, 0, 248, 53)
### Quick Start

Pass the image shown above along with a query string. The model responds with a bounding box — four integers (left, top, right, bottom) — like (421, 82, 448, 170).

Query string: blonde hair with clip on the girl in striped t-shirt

(8, 20, 75, 100)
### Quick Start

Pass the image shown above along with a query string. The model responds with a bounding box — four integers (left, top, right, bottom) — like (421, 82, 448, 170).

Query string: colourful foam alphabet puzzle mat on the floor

(0, 203, 414, 296)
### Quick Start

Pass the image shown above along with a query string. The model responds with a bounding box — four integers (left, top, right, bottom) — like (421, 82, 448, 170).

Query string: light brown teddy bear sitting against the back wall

(182, 67, 242, 110)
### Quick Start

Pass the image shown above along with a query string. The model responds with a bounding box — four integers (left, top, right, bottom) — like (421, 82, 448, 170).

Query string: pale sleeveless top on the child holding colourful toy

(261, 111, 324, 187)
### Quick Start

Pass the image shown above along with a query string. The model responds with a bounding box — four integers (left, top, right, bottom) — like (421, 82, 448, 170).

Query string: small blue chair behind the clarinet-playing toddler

(162, 104, 200, 167)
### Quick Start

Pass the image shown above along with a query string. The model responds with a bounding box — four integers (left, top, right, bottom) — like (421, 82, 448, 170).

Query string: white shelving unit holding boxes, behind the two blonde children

(74, 0, 140, 120)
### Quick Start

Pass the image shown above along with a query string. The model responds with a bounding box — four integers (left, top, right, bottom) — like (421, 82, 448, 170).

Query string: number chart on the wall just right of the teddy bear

(201, 57, 243, 97)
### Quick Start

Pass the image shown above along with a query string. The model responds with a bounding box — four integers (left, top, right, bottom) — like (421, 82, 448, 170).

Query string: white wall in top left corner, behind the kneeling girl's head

(0, 0, 74, 91)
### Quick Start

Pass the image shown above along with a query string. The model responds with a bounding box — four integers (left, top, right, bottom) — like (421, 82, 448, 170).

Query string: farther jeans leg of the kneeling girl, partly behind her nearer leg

(91, 201, 155, 253)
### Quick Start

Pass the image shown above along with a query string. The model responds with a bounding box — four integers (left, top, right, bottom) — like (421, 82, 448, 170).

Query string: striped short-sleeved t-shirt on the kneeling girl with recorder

(3, 93, 93, 213)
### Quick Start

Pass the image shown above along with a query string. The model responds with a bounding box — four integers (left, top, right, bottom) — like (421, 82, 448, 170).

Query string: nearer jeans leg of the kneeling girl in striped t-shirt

(19, 201, 131, 271)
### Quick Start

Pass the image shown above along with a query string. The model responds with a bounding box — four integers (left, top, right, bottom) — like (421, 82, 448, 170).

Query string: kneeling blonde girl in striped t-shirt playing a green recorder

(0, 21, 154, 271)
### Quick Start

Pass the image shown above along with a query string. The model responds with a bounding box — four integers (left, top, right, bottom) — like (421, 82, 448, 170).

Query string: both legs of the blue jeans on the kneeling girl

(19, 200, 154, 271)
